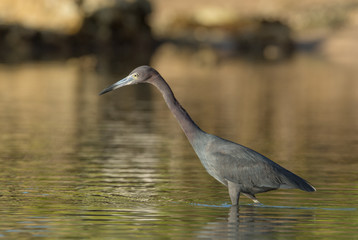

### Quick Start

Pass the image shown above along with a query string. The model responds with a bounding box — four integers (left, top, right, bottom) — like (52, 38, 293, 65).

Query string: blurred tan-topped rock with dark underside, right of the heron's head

(165, 8, 294, 61)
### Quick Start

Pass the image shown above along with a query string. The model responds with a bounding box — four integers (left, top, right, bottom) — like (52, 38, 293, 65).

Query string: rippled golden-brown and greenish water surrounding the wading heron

(0, 51, 358, 239)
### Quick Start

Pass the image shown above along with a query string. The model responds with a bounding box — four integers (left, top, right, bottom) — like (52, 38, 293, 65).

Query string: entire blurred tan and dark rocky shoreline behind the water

(0, 0, 358, 64)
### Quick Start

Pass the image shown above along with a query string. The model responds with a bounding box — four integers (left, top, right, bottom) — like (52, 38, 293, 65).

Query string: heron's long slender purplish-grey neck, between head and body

(150, 76, 203, 143)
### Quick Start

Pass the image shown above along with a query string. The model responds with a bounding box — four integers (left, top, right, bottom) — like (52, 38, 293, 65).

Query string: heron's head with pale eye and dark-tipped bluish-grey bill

(99, 66, 159, 95)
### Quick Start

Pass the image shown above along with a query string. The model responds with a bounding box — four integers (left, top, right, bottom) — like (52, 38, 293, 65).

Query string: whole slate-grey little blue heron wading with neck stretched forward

(100, 66, 316, 206)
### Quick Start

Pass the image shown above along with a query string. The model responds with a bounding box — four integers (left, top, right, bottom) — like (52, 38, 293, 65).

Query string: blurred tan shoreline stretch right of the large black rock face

(151, 0, 358, 61)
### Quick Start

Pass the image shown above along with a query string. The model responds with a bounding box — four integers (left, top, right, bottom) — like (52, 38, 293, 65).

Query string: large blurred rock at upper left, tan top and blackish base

(0, 0, 153, 63)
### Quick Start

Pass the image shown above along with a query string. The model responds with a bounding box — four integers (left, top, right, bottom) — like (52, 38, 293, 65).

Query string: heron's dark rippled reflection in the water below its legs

(194, 205, 314, 239)
